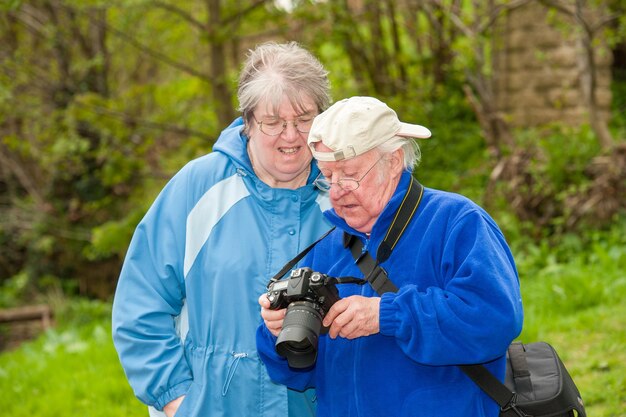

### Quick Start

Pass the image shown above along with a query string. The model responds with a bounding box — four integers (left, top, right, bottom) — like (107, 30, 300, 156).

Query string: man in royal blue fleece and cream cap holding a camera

(257, 97, 522, 417)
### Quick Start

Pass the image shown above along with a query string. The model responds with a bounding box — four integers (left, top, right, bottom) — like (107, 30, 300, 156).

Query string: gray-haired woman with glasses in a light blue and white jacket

(113, 43, 330, 417)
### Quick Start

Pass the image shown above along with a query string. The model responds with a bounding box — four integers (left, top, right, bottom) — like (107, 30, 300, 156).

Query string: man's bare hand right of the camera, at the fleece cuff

(323, 295, 380, 339)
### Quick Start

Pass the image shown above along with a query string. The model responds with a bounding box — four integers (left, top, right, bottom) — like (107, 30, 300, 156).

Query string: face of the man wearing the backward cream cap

(315, 143, 403, 233)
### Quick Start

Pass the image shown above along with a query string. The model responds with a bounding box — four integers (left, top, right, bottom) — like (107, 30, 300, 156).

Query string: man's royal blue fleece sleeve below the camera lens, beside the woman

(256, 322, 315, 391)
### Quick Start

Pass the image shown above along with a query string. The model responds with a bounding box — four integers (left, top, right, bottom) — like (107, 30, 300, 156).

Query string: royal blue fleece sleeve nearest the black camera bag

(380, 210, 523, 365)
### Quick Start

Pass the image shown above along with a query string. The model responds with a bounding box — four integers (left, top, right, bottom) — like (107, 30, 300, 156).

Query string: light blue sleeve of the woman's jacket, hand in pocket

(112, 170, 192, 410)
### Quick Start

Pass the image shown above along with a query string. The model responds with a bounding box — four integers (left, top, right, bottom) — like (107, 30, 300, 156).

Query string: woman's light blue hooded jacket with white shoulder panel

(113, 118, 330, 417)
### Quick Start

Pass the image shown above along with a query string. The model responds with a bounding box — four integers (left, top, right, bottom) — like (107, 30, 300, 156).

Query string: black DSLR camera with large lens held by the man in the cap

(267, 268, 339, 368)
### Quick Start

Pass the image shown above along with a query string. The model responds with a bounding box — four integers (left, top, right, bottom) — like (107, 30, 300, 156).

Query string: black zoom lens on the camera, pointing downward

(276, 301, 322, 368)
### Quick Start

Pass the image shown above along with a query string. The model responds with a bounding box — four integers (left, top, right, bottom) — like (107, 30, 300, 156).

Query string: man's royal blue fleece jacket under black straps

(257, 172, 523, 417)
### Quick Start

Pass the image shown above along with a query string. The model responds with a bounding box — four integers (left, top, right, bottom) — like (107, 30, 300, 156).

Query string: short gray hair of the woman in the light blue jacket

(237, 42, 331, 131)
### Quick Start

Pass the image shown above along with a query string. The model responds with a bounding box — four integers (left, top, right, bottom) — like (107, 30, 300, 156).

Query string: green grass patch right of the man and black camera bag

(516, 219, 626, 417)
